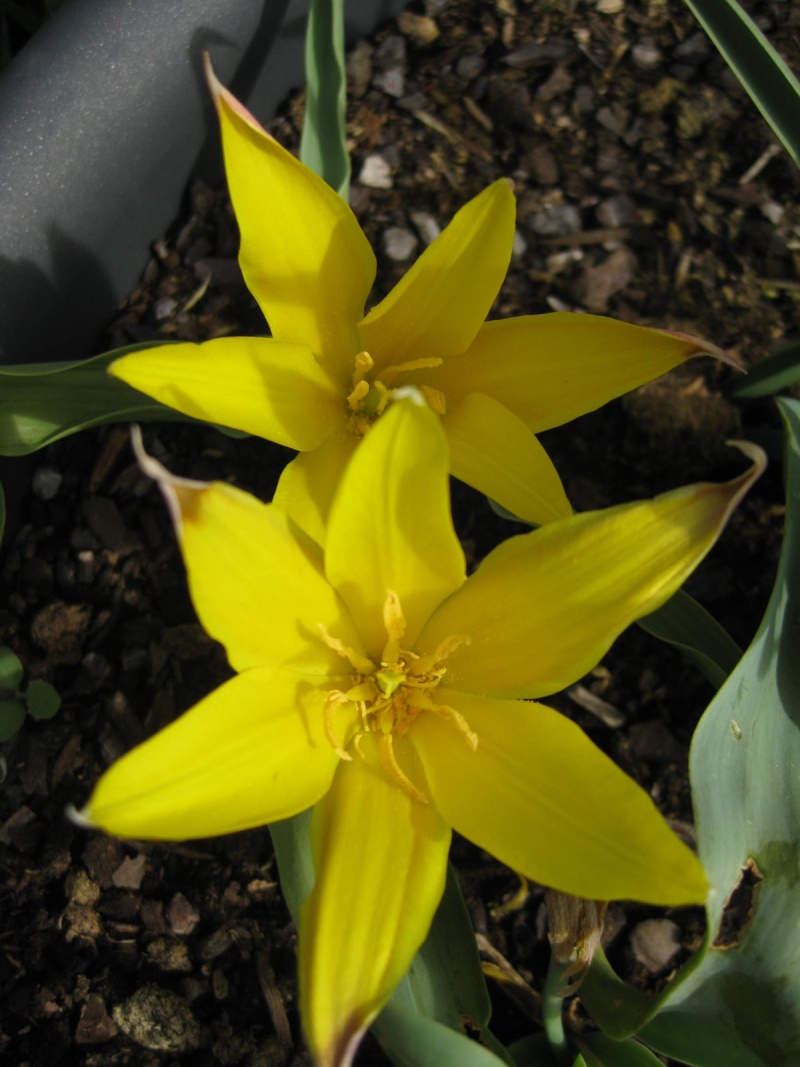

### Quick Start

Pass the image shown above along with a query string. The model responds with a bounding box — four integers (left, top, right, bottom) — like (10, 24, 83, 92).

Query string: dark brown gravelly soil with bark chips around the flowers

(0, 0, 800, 1067)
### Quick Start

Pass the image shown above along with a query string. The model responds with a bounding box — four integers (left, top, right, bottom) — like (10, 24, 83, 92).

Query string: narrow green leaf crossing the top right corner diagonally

(686, 0, 800, 166)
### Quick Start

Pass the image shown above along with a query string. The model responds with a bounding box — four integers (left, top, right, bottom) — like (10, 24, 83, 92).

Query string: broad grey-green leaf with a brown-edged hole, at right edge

(641, 399, 800, 1067)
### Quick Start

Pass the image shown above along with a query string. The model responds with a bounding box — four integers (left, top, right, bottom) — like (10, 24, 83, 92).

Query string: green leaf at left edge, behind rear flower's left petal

(0, 344, 195, 456)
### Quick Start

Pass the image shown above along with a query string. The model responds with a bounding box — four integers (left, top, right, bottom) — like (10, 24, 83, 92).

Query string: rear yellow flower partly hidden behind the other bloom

(106, 60, 720, 543)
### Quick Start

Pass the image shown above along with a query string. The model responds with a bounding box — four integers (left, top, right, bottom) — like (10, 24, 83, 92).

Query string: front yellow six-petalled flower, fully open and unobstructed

(82, 391, 761, 1065)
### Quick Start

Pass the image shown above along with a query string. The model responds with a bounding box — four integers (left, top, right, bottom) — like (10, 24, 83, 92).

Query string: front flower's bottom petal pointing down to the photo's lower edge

(299, 734, 450, 1067)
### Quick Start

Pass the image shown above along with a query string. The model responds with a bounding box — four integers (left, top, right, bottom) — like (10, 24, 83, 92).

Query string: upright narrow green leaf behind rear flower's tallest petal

(300, 0, 350, 200)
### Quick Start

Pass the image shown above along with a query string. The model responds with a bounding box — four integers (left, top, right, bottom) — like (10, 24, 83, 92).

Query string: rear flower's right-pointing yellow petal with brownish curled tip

(417, 312, 724, 433)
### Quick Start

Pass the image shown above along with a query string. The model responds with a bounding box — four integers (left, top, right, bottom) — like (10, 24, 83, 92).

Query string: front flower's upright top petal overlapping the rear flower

(325, 394, 464, 659)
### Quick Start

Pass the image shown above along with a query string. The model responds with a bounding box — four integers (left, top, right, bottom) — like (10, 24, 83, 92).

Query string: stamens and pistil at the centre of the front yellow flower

(319, 589, 478, 803)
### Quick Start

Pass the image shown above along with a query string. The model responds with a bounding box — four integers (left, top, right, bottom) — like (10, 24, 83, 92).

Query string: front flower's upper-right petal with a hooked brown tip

(416, 445, 765, 697)
